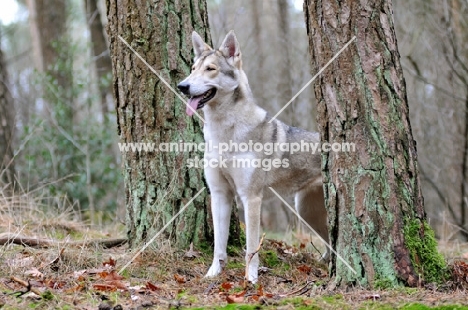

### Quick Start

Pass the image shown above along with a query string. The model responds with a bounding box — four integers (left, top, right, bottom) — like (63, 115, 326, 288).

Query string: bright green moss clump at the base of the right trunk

(404, 219, 449, 283)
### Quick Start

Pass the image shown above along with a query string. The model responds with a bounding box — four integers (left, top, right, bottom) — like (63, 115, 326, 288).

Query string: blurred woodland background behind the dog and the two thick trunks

(0, 0, 468, 242)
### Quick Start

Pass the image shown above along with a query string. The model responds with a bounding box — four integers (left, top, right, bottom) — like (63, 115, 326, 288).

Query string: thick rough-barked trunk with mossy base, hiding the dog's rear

(304, 0, 446, 287)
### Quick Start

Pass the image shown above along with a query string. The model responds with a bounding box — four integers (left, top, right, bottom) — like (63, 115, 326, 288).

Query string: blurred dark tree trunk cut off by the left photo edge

(0, 50, 15, 185)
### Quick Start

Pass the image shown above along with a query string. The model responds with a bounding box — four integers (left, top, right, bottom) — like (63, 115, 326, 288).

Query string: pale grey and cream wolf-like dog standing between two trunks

(177, 30, 329, 283)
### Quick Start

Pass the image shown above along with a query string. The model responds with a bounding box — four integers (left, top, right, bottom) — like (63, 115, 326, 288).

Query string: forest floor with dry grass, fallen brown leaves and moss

(0, 197, 468, 310)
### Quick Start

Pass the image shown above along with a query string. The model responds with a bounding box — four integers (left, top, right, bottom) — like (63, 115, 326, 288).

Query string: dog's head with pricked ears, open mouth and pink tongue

(177, 30, 246, 116)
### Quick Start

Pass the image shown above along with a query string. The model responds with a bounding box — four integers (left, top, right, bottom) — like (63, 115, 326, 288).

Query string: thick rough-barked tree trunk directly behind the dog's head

(107, 0, 230, 248)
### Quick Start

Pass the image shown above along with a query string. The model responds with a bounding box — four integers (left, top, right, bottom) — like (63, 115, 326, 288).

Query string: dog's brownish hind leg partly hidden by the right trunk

(295, 185, 329, 260)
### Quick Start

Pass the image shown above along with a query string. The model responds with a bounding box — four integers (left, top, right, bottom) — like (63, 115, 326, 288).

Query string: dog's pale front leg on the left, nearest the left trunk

(205, 168, 234, 277)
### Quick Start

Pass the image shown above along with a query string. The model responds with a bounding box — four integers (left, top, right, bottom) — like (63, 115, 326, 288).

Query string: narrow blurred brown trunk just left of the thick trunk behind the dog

(84, 0, 112, 119)
